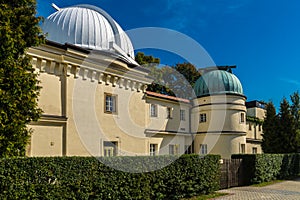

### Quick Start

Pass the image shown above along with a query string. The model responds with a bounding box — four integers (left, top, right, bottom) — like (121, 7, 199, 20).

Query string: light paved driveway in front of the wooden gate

(215, 178, 300, 200)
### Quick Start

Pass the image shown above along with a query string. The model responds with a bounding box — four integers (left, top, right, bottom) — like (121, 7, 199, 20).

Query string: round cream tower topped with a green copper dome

(191, 68, 246, 158)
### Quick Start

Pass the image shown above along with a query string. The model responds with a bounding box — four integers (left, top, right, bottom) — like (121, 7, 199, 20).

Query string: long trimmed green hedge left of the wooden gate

(0, 155, 220, 199)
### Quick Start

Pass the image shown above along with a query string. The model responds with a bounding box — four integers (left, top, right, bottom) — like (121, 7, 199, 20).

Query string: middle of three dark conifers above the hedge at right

(278, 98, 297, 153)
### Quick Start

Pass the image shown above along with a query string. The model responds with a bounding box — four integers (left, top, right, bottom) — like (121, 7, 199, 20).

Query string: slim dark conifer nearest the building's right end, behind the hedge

(262, 102, 280, 153)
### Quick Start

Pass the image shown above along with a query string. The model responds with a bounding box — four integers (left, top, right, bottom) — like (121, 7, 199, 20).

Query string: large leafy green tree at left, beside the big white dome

(0, 0, 44, 157)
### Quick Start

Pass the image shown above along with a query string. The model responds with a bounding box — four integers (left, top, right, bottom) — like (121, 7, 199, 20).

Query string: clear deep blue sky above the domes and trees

(37, 0, 300, 105)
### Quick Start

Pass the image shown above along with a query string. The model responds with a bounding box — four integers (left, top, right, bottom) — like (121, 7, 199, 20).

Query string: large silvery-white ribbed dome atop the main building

(41, 5, 134, 58)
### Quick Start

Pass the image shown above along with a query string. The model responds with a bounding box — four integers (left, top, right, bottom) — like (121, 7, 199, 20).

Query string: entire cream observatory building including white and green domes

(27, 5, 264, 158)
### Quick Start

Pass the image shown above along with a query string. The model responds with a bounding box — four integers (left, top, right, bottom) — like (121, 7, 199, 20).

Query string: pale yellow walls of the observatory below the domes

(27, 42, 262, 158)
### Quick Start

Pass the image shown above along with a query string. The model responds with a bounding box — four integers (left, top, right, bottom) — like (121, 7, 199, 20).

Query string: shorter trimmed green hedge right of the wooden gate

(231, 154, 300, 185)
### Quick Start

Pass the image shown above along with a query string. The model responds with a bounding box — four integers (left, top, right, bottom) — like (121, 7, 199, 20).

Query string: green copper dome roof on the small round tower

(194, 70, 243, 97)
